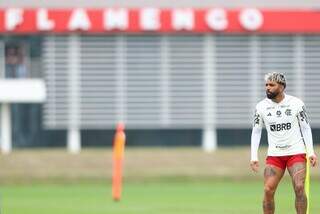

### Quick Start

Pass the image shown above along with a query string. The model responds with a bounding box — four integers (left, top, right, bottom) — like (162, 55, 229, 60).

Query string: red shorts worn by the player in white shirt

(266, 154, 306, 170)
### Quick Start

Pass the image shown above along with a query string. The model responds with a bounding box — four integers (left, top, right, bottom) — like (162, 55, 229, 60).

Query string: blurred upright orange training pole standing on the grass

(112, 123, 126, 201)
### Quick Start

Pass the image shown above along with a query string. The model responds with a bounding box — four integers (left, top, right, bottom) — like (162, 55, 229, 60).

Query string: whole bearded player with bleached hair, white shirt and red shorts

(250, 72, 317, 214)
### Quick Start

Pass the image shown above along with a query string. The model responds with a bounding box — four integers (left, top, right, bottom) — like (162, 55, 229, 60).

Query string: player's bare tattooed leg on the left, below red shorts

(263, 164, 285, 214)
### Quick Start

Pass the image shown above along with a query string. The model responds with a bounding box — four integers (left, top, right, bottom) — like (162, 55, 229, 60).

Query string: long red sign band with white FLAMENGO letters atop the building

(0, 8, 320, 34)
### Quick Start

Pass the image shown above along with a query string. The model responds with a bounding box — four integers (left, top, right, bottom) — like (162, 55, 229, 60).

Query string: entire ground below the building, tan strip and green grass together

(0, 147, 320, 214)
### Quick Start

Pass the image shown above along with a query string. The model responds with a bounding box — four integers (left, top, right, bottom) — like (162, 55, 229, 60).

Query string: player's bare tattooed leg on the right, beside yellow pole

(288, 162, 307, 214)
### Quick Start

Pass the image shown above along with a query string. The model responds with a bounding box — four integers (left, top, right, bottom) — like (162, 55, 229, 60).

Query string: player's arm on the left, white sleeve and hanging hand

(250, 108, 263, 172)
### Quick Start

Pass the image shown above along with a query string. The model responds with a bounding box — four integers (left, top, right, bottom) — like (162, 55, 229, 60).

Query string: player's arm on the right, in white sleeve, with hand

(297, 105, 318, 166)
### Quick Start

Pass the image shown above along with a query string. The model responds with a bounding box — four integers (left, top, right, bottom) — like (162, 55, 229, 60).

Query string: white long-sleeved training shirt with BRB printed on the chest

(251, 94, 314, 160)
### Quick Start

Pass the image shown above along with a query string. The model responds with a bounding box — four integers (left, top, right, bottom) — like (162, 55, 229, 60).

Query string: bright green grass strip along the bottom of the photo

(1, 180, 320, 214)
